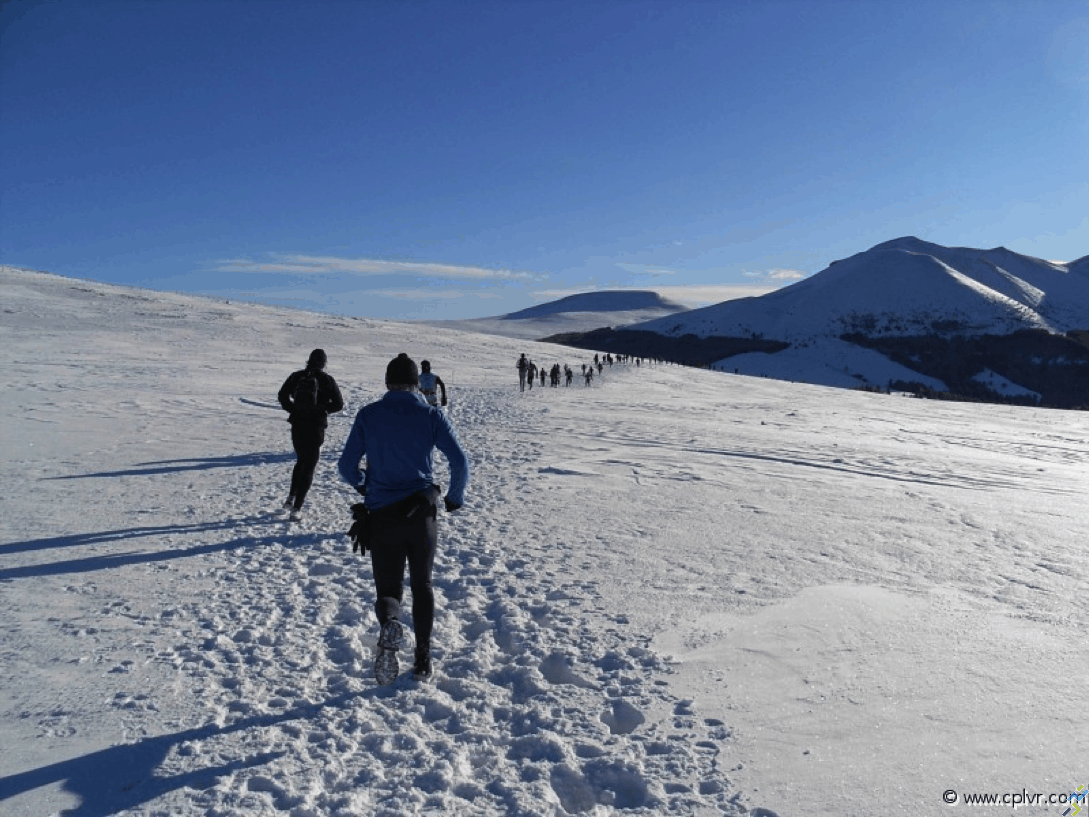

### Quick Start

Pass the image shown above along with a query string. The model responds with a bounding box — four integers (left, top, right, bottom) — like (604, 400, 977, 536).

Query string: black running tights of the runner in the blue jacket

(370, 515, 439, 645)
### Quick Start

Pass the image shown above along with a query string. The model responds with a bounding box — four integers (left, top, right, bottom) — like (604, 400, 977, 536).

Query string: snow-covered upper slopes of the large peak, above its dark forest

(633, 237, 1089, 342)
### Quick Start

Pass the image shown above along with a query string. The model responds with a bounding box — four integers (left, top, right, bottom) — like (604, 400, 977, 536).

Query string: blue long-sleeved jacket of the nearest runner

(337, 391, 469, 511)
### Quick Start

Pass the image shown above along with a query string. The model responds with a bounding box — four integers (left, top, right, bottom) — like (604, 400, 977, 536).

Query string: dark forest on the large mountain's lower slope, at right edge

(841, 329, 1089, 411)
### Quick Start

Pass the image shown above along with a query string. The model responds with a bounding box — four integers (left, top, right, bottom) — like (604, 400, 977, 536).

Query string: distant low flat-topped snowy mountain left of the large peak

(418, 290, 688, 340)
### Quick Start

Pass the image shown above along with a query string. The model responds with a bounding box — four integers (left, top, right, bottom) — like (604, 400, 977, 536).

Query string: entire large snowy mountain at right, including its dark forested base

(549, 236, 1089, 409)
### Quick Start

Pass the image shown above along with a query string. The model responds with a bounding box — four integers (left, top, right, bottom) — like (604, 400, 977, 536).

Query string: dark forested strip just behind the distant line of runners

(542, 327, 791, 366)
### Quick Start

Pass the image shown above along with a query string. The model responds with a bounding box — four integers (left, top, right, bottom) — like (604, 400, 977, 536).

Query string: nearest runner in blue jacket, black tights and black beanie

(338, 354, 469, 684)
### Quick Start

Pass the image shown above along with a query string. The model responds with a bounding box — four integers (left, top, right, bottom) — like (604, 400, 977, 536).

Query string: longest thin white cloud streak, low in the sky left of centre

(213, 255, 539, 280)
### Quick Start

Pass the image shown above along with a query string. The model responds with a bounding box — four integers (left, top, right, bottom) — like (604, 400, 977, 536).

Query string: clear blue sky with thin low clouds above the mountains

(0, 0, 1089, 319)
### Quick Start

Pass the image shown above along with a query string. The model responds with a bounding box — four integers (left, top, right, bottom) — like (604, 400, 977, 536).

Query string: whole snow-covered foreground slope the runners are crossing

(0, 269, 1089, 817)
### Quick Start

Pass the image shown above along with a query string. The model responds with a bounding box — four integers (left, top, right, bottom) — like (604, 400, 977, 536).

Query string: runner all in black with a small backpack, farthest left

(277, 349, 344, 520)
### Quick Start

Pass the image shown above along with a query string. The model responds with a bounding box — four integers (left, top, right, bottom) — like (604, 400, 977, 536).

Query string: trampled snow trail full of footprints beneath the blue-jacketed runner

(187, 390, 742, 815)
